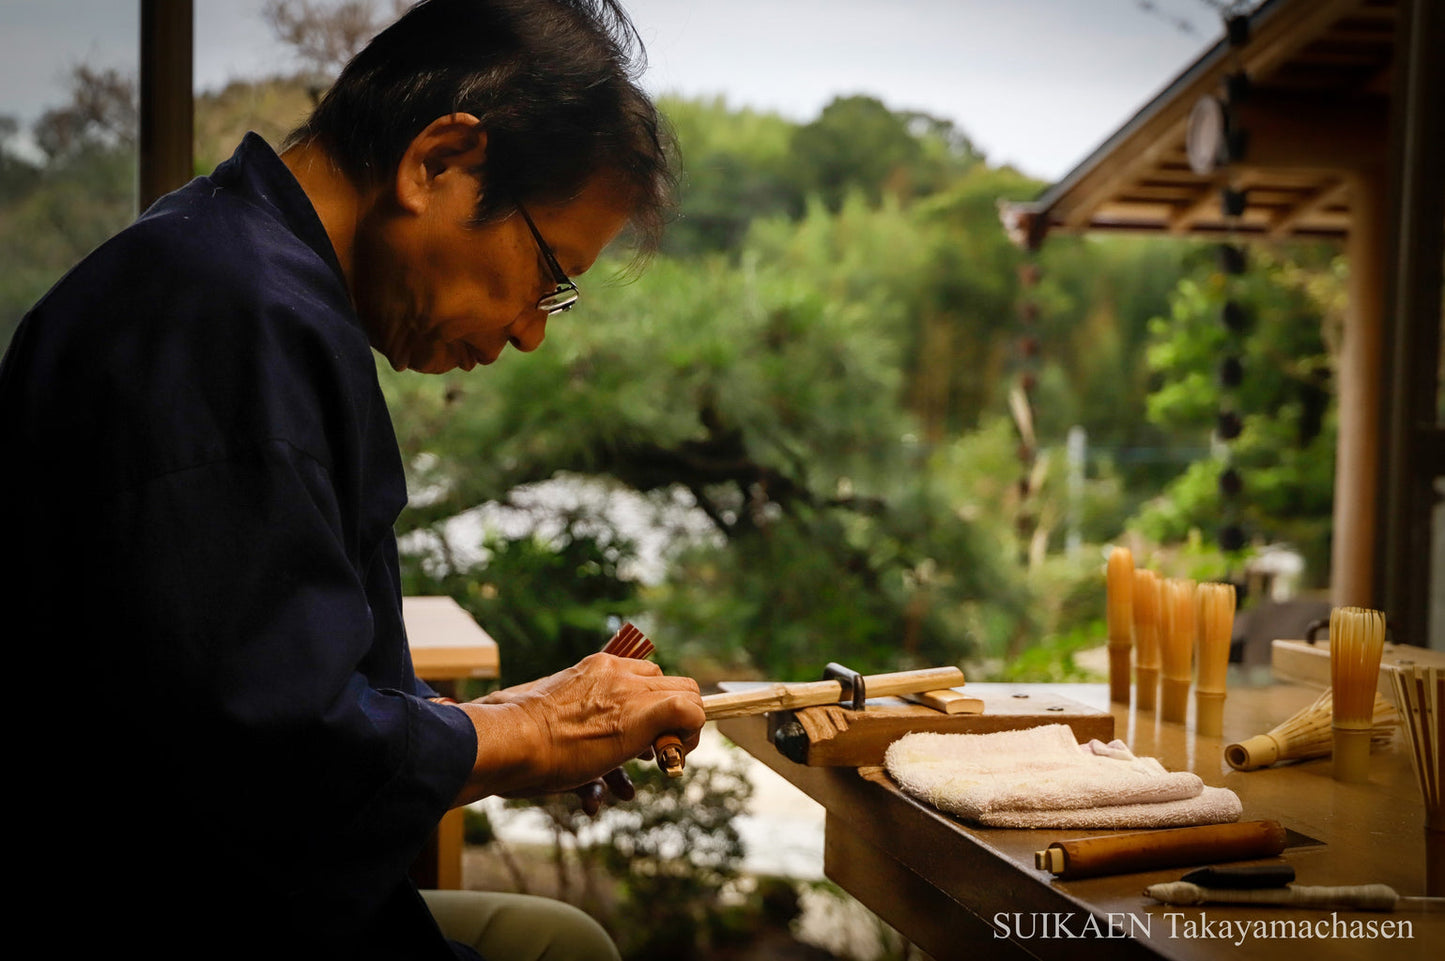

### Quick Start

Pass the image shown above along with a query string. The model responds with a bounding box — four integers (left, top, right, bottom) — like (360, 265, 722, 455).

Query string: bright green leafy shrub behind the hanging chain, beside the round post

(1131, 249, 1342, 581)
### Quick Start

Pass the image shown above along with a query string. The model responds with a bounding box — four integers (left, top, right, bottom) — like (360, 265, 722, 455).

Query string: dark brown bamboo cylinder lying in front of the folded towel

(1033, 821, 1285, 880)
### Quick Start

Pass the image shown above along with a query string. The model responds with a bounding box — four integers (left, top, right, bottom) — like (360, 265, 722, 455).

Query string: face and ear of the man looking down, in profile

(353, 169, 631, 373)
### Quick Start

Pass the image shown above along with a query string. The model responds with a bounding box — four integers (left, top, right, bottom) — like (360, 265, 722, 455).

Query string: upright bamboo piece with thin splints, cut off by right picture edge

(1390, 665, 1445, 896)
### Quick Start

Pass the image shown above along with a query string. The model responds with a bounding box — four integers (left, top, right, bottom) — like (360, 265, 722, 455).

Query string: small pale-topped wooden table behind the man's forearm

(402, 597, 500, 889)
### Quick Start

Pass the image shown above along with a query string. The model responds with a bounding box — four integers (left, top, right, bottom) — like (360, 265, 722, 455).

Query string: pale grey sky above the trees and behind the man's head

(0, 0, 1221, 181)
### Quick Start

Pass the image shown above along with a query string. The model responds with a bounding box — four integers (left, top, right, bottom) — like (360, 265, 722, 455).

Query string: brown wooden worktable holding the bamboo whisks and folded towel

(718, 685, 1445, 961)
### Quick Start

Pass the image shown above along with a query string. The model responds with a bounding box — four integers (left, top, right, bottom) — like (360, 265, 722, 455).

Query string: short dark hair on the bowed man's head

(296, 0, 673, 250)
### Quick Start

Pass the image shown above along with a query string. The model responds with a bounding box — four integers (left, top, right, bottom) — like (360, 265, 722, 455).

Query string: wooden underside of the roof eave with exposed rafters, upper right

(1004, 0, 1397, 243)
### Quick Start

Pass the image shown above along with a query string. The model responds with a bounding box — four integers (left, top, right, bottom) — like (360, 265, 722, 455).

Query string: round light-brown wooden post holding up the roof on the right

(1329, 169, 1386, 607)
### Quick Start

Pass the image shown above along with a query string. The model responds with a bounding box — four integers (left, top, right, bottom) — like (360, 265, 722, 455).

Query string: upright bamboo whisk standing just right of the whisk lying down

(1329, 607, 1384, 783)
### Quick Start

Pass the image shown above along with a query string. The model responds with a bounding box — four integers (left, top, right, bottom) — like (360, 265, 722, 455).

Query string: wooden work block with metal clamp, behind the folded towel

(721, 682, 1114, 767)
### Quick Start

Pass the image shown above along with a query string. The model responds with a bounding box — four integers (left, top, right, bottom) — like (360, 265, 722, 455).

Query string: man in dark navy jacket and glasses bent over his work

(0, 0, 704, 960)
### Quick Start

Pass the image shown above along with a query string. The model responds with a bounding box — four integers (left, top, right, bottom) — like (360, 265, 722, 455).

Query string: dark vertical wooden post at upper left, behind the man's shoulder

(136, 0, 195, 210)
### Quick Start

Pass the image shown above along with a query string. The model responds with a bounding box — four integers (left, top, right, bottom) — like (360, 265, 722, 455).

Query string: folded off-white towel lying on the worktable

(883, 724, 1243, 828)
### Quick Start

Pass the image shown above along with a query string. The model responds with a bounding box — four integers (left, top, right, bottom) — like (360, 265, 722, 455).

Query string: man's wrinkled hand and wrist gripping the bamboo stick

(447, 653, 705, 814)
